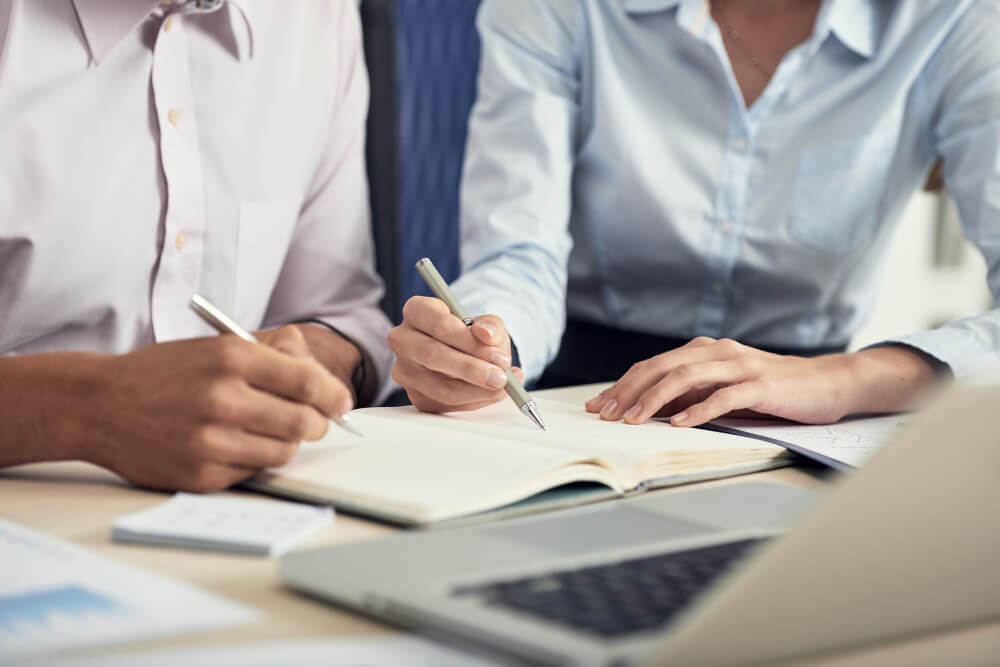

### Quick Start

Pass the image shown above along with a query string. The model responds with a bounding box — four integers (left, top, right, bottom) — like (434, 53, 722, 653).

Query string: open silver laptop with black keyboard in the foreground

(279, 387, 1000, 665)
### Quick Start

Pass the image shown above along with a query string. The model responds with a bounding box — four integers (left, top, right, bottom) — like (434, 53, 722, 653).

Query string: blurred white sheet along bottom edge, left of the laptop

(53, 635, 509, 667)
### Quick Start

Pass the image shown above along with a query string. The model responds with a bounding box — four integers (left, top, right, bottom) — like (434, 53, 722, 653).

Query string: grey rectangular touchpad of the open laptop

(486, 507, 718, 555)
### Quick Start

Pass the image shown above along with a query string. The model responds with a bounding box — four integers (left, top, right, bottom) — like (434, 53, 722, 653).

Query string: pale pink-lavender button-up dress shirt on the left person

(0, 0, 392, 396)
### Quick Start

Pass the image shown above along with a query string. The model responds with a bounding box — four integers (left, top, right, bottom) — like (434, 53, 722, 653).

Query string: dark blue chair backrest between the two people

(361, 0, 480, 321)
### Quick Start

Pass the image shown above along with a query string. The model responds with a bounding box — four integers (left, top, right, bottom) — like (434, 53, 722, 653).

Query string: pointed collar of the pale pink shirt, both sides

(73, 0, 253, 65)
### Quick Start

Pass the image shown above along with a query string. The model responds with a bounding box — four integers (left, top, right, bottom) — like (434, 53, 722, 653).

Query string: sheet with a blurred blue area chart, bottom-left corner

(0, 519, 257, 664)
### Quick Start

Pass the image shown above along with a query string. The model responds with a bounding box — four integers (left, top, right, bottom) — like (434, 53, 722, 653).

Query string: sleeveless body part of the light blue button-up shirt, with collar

(568, 0, 969, 347)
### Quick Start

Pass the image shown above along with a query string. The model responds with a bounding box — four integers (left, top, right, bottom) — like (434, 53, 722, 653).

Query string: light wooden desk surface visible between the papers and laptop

(0, 389, 1000, 667)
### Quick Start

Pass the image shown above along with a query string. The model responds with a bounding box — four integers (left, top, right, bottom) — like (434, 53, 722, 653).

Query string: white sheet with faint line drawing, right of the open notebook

(713, 414, 908, 470)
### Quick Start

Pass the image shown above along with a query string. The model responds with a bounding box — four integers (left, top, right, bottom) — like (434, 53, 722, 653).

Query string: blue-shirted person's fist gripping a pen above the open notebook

(389, 296, 524, 412)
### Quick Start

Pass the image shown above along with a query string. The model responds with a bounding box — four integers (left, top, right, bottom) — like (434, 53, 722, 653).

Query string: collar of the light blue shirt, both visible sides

(622, 0, 880, 58)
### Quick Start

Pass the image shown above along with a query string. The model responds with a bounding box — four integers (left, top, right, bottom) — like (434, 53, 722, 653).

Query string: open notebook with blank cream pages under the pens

(247, 399, 793, 525)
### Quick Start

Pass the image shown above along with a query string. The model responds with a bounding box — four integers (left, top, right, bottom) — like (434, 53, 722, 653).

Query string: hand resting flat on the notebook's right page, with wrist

(586, 337, 937, 426)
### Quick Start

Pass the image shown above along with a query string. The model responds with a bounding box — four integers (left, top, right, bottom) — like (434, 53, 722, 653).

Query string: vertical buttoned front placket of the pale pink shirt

(151, 13, 205, 342)
